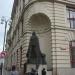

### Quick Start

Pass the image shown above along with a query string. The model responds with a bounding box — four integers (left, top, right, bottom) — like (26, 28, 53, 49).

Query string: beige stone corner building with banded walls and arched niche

(5, 0, 75, 75)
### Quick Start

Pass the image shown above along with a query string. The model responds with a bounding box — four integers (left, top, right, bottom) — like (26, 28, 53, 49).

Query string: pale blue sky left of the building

(0, 0, 14, 52)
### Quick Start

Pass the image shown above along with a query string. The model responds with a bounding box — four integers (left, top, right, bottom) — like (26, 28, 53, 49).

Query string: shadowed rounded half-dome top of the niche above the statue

(29, 13, 51, 33)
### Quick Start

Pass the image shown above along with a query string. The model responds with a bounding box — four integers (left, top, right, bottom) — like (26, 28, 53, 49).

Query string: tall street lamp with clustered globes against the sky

(1, 17, 11, 51)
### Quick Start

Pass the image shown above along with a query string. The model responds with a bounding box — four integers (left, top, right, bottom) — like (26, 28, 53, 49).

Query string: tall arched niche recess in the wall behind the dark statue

(29, 13, 52, 69)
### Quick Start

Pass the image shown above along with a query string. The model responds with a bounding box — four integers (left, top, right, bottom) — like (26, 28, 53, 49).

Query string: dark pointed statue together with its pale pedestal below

(26, 32, 47, 75)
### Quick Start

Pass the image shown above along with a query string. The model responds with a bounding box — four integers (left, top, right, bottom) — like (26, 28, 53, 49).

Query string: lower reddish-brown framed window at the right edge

(70, 40, 75, 68)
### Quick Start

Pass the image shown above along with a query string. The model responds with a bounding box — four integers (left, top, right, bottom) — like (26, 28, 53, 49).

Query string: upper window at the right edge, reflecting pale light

(67, 8, 75, 29)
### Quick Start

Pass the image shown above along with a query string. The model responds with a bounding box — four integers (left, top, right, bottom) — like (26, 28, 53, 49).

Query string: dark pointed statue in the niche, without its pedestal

(27, 32, 46, 65)
